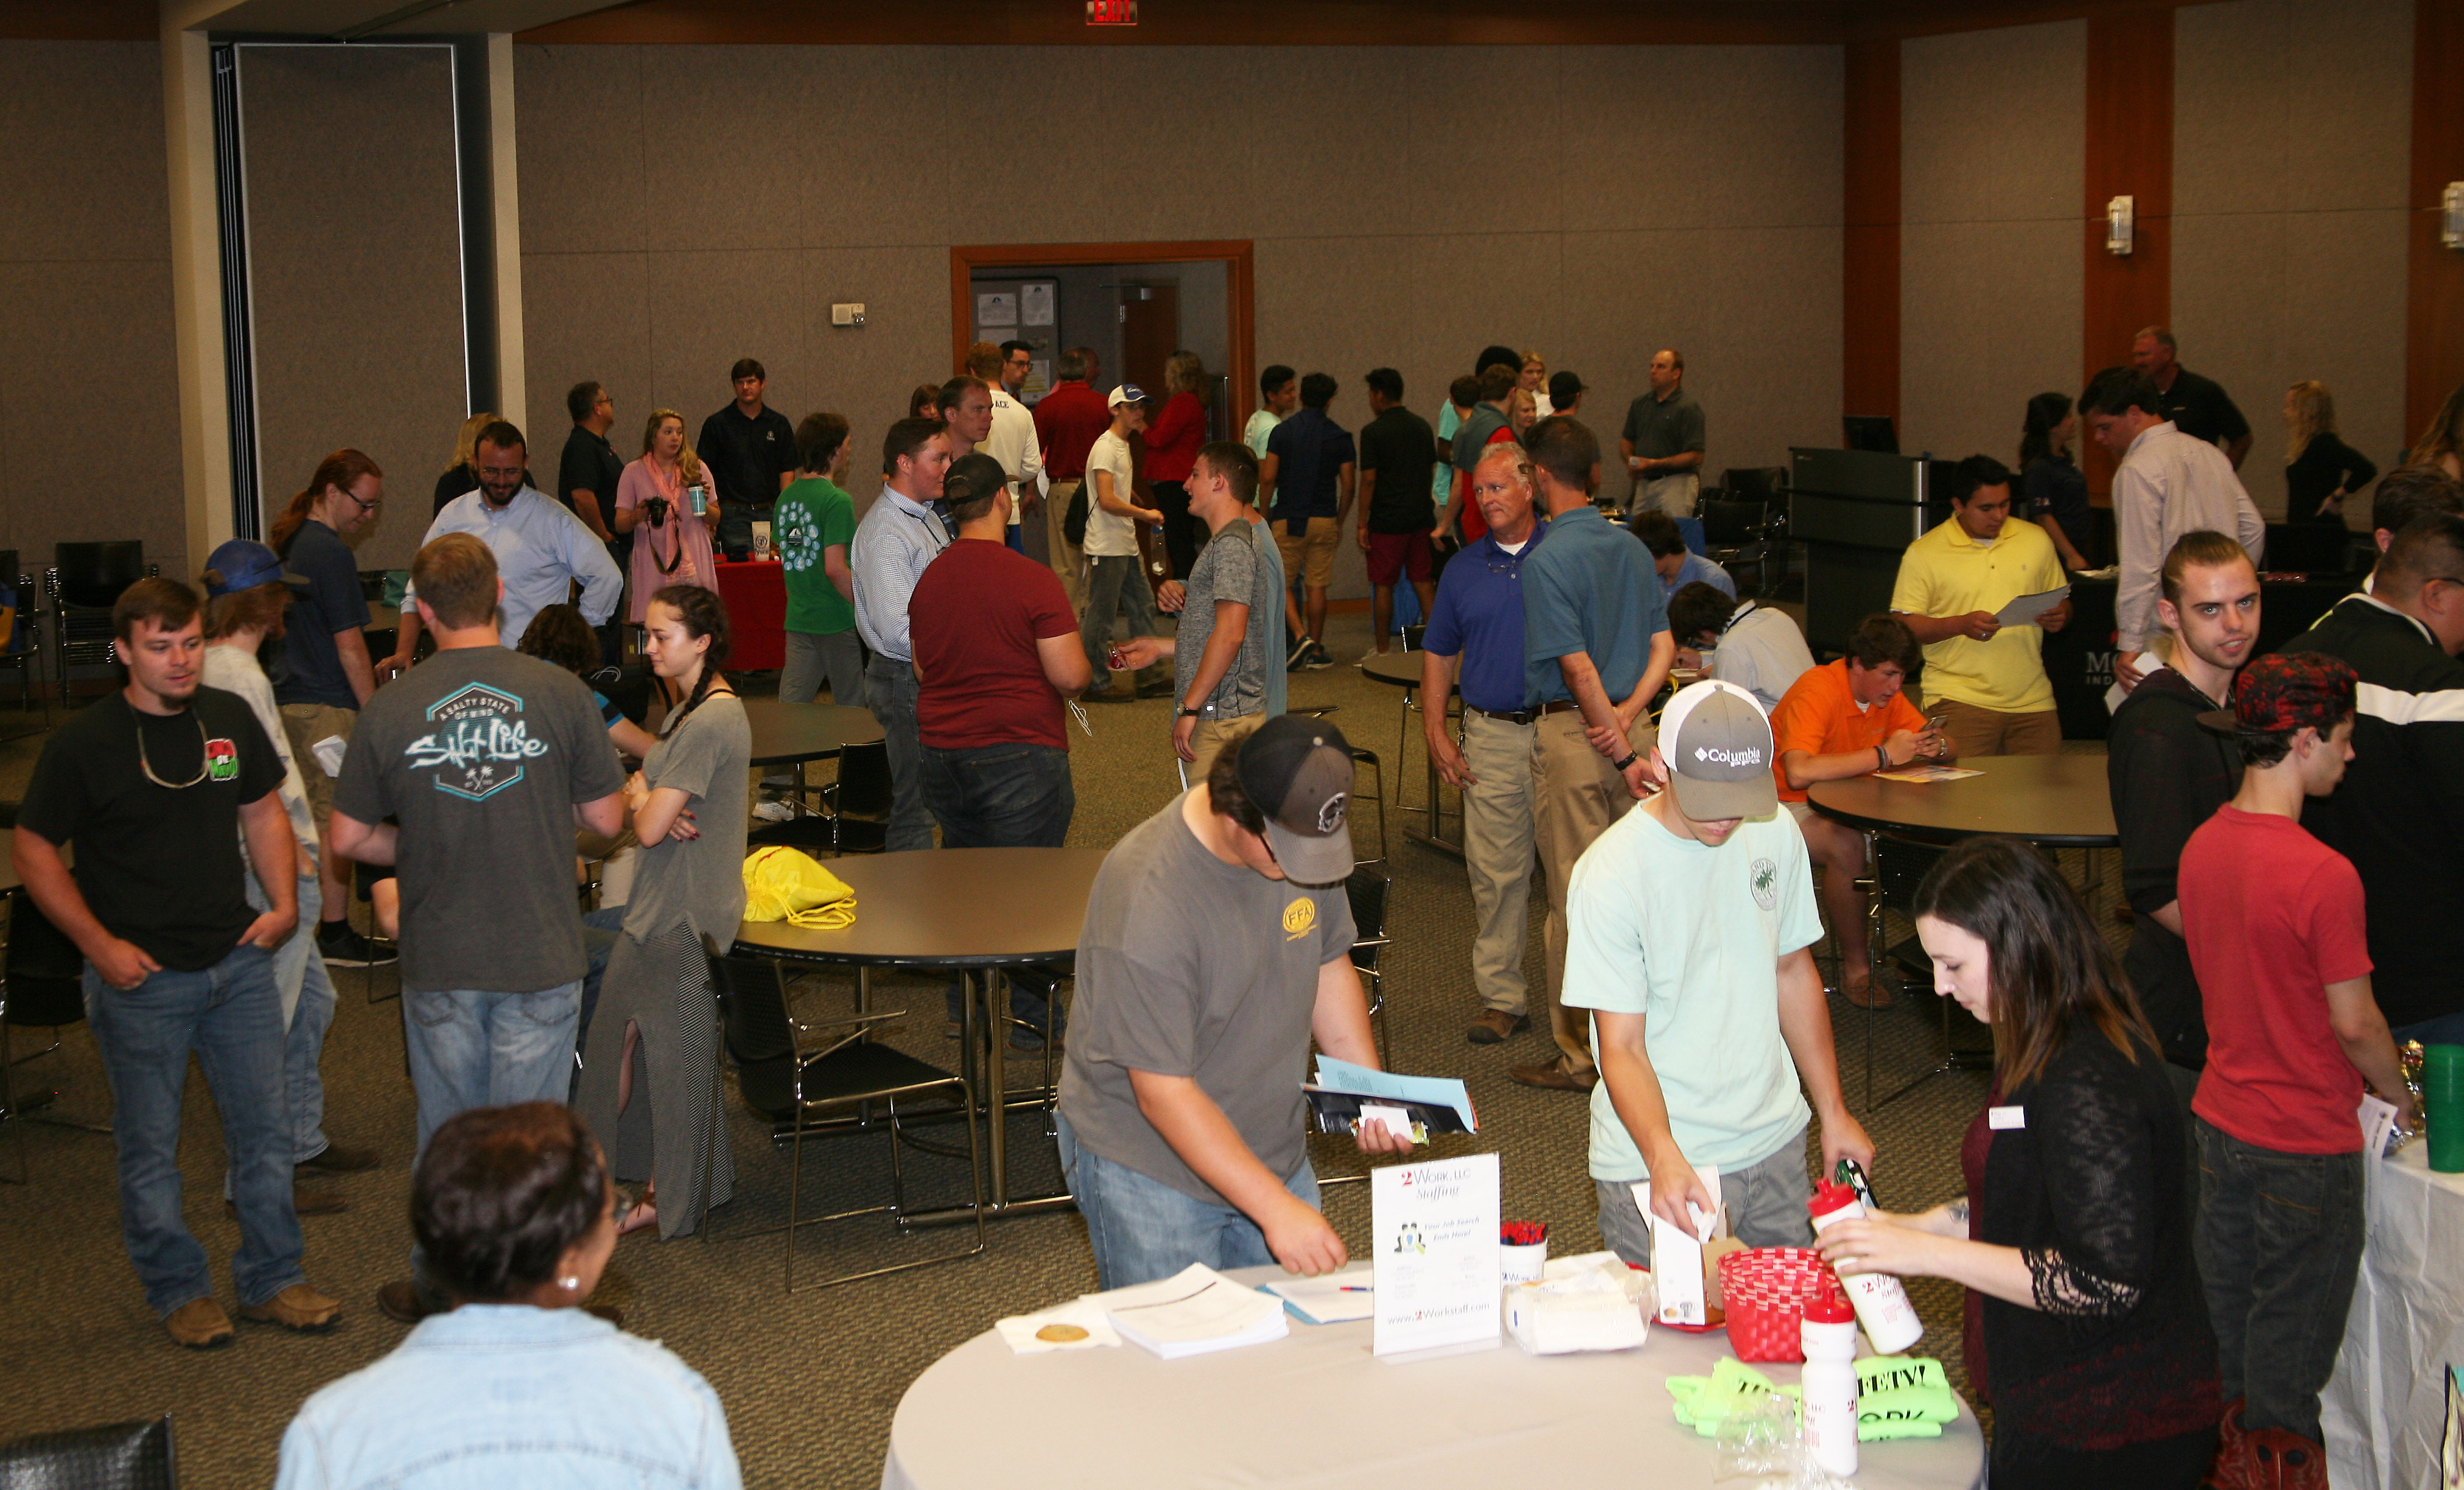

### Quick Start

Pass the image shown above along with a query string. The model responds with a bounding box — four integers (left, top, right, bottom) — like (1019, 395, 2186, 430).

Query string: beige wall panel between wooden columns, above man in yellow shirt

(1900, 22, 2087, 463)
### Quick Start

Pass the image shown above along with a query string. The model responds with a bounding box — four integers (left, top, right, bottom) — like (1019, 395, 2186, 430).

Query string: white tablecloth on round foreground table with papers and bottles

(882, 1268, 1986, 1490)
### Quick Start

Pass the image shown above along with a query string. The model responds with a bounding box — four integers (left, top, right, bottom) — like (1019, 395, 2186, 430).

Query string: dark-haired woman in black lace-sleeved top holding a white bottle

(1821, 838, 2220, 1490)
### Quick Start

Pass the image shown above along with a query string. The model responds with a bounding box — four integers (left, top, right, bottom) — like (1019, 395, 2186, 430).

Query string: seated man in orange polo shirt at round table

(1772, 616, 1949, 1007)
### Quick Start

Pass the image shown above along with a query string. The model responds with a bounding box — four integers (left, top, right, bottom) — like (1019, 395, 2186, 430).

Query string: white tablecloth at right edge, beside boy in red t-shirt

(2321, 1140, 2464, 1490)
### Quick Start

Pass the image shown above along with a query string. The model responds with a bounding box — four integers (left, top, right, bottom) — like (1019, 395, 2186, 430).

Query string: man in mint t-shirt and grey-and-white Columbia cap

(1562, 682, 1872, 1264)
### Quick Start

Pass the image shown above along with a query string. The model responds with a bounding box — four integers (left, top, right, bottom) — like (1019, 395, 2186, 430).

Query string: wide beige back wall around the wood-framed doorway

(515, 47, 1841, 593)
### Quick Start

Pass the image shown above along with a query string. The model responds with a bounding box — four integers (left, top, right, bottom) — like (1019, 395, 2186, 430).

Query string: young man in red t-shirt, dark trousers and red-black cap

(2180, 652, 2412, 1485)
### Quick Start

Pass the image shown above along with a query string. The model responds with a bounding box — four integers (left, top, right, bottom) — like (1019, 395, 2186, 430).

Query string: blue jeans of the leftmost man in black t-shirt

(84, 946, 308, 1315)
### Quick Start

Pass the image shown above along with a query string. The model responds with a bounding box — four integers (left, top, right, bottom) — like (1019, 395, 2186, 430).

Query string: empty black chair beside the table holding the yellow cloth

(702, 939, 983, 1293)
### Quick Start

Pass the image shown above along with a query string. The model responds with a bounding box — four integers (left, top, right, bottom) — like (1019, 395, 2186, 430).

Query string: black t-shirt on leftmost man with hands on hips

(17, 687, 291, 973)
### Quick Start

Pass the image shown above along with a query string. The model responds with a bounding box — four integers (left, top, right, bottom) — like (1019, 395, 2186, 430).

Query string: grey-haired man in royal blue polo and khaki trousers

(1419, 443, 1557, 1044)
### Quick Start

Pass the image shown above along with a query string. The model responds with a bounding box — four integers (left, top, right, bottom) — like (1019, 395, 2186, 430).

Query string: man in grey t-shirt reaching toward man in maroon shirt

(1121, 441, 1284, 781)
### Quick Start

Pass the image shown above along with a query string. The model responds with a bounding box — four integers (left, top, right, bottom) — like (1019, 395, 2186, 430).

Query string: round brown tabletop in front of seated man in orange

(1806, 756, 2121, 850)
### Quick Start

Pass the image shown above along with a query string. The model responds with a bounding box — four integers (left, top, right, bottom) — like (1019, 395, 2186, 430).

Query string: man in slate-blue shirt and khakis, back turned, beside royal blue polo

(1505, 414, 1678, 1091)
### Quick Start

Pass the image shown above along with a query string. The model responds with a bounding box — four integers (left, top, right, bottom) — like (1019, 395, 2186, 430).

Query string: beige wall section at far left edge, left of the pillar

(0, 42, 182, 586)
